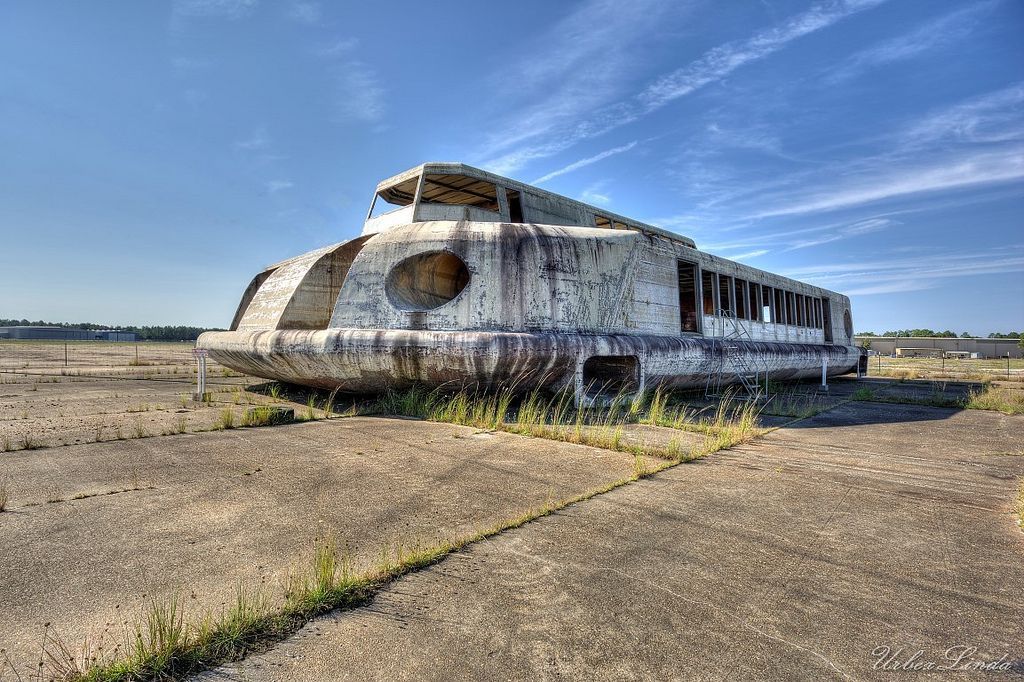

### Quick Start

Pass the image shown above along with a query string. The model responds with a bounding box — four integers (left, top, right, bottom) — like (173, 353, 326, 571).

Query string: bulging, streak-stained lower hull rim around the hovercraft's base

(198, 329, 861, 392)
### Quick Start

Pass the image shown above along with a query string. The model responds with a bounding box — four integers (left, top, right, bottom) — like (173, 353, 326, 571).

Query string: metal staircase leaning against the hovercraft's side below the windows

(705, 309, 768, 402)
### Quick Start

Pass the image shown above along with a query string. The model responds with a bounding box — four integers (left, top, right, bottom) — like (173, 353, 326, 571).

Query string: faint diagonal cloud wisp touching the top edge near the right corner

(825, 0, 998, 85)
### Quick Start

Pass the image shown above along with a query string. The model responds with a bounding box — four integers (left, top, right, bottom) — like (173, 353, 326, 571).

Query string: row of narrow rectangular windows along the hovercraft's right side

(700, 270, 824, 329)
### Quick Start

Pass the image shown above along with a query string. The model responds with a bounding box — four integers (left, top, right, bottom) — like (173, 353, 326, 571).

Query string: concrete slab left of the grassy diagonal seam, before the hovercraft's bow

(0, 417, 647, 663)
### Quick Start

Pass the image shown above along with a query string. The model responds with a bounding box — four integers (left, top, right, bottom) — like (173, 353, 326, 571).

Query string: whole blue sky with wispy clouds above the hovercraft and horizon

(0, 0, 1024, 335)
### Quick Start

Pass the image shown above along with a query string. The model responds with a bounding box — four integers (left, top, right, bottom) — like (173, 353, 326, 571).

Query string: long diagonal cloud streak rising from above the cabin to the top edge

(483, 0, 885, 173)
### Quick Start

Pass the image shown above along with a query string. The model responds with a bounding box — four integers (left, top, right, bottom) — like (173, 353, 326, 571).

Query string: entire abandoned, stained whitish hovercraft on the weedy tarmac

(198, 163, 866, 400)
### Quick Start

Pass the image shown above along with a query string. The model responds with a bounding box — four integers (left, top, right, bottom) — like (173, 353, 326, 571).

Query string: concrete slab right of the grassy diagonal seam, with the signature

(201, 402, 1024, 682)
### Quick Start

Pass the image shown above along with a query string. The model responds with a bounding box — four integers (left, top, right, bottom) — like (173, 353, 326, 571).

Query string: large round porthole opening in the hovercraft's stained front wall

(384, 251, 469, 311)
